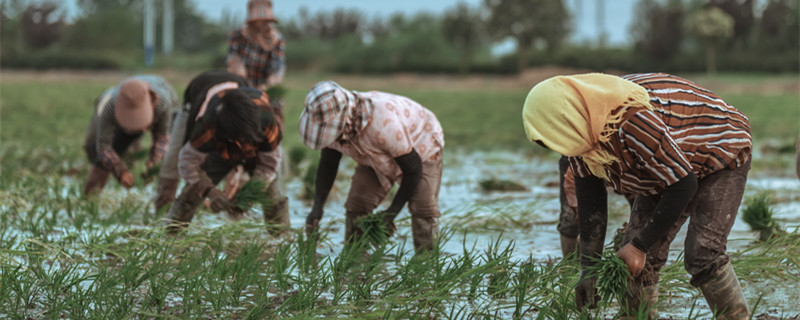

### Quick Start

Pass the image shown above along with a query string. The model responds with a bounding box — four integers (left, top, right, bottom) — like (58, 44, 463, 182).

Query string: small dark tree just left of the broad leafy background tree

(442, 3, 485, 73)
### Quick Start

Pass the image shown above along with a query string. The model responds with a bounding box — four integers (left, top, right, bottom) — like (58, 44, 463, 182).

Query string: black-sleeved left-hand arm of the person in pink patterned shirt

(306, 148, 342, 234)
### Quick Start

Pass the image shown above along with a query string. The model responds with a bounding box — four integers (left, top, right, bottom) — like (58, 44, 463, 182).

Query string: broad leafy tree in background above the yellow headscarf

(484, 0, 570, 71)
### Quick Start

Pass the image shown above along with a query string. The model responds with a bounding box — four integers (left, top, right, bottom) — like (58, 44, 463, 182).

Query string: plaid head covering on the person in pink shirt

(300, 81, 373, 150)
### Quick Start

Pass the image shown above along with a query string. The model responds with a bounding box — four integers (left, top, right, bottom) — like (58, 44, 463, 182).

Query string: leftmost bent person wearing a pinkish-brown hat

(83, 75, 178, 195)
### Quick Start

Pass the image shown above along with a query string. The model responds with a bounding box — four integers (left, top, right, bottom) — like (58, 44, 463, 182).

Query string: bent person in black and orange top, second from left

(155, 71, 289, 234)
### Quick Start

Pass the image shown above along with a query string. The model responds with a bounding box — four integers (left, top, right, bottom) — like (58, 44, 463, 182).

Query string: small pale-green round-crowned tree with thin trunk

(686, 7, 734, 74)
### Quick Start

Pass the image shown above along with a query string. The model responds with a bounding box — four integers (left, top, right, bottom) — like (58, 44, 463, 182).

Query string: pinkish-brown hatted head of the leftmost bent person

(114, 79, 158, 133)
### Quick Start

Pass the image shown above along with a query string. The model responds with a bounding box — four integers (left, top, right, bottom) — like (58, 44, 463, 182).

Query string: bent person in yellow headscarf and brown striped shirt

(522, 73, 752, 319)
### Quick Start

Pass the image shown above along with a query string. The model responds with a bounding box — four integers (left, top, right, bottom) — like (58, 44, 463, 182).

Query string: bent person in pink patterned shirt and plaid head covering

(300, 81, 444, 251)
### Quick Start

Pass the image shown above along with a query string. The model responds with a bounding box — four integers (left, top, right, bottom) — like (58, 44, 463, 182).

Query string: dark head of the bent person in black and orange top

(215, 89, 264, 151)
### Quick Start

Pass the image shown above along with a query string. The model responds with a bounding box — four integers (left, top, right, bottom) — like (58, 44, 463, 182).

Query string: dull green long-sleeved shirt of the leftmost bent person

(95, 75, 179, 178)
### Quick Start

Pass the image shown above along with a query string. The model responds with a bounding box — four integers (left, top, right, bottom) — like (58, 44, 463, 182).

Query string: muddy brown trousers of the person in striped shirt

(623, 161, 750, 312)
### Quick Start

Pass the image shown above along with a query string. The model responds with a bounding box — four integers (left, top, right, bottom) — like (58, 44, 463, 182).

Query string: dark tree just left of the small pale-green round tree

(631, 0, 684, 60)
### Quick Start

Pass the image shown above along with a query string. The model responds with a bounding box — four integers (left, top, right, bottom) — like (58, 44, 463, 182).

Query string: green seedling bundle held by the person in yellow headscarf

(586, 250, 631, 302)
